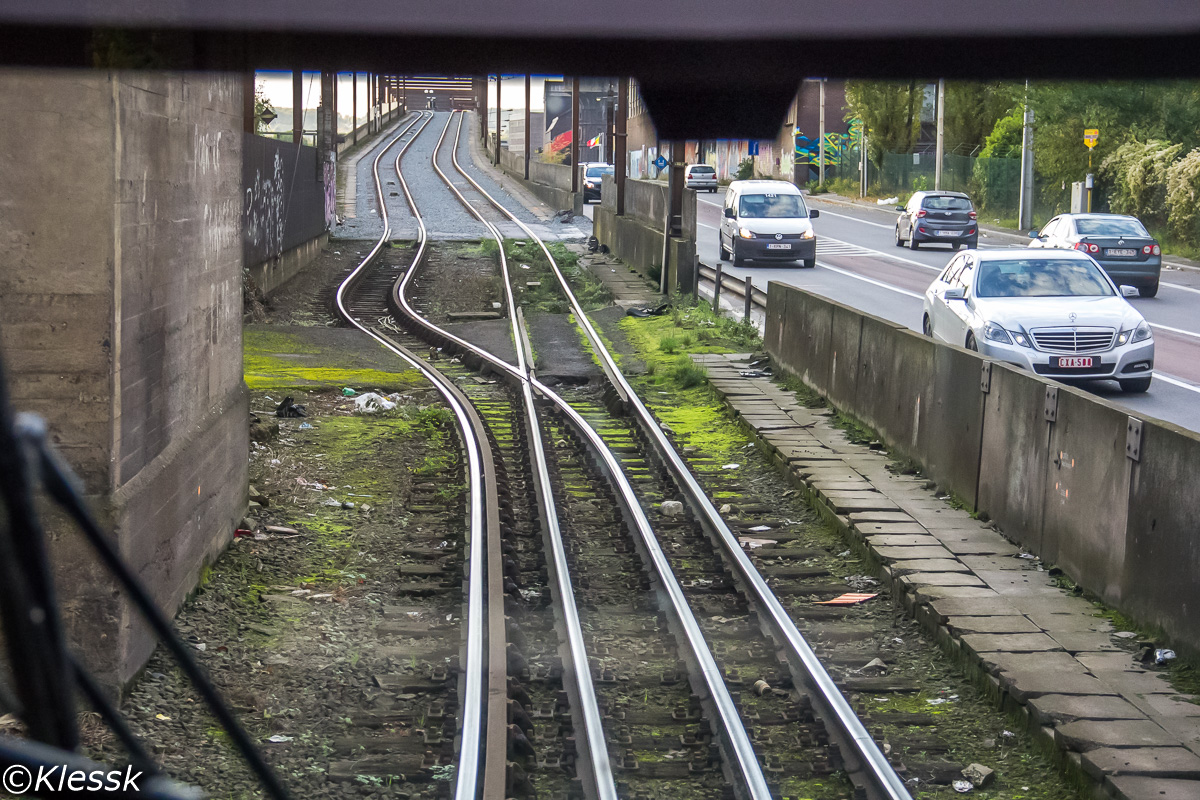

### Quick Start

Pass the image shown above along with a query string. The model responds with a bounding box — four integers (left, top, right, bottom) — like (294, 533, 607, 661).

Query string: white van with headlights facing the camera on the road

(718, 181, 821, 269)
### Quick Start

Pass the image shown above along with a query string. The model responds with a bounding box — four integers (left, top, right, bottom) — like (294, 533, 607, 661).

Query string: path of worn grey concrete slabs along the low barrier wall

(696, 355, 1200, 800)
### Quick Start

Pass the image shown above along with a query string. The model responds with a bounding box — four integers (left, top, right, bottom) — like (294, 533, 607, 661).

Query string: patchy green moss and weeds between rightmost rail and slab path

(619, 307, 1081, 800)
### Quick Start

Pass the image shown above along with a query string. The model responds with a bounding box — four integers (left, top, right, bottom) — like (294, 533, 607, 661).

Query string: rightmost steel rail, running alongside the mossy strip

(448, 112, 912, 800)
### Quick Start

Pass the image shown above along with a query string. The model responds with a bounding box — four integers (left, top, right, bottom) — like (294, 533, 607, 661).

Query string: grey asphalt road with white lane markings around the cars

(696, 192, 1200, 431)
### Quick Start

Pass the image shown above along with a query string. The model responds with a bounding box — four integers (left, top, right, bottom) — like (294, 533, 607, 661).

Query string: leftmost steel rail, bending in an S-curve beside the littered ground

(336, 114, 506, 800)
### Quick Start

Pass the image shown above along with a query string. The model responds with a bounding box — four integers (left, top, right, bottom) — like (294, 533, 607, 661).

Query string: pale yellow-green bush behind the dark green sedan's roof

(1099, 139, 1183, 227)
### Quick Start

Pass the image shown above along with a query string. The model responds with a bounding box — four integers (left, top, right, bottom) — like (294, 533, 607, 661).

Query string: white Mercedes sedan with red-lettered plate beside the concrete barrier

(922, 248, 1154, 392)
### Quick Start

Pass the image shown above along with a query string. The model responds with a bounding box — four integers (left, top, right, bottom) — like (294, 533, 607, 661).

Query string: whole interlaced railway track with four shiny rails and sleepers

(337, 113, 908, 800)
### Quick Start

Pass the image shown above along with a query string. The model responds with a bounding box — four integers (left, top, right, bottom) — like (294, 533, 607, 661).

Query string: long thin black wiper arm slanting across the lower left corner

(26, 422, 288, 800)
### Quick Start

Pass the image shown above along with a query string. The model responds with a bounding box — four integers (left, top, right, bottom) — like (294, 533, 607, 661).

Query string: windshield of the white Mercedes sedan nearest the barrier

(976, 258, 1112, 297)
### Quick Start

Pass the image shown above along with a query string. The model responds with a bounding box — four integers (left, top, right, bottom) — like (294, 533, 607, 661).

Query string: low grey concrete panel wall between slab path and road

(768, 281, 1200, 654)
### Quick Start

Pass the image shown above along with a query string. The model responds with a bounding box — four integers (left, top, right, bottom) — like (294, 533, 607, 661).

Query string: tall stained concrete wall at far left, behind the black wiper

(0, 71, 248, 687)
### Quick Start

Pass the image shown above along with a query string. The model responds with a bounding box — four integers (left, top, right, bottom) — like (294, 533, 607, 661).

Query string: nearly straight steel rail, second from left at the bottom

(433, 113, 618, 800)
